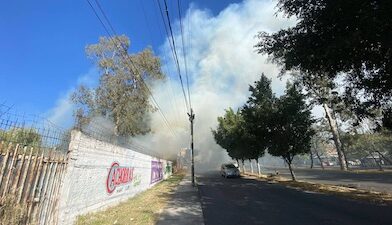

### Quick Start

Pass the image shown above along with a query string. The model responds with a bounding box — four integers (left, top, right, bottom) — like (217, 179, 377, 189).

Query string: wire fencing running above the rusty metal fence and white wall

(0, 103, 165, 158)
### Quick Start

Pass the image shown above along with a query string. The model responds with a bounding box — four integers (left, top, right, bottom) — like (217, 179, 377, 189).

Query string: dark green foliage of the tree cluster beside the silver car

(212, 74, 314, 176)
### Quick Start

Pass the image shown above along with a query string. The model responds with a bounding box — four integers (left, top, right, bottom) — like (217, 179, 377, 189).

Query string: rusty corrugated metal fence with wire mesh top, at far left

(0, 104, 69, 224)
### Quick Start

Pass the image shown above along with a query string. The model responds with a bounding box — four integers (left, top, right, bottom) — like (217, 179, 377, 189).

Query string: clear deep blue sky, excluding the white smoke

(0, 0, 239, 114)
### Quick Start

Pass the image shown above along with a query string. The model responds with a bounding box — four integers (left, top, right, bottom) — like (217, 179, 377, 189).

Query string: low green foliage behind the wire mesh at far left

(0, 128, 42, 146)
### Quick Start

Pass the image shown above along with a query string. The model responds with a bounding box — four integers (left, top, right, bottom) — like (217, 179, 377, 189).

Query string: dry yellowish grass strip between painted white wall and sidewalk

(76, 174, 184, 225)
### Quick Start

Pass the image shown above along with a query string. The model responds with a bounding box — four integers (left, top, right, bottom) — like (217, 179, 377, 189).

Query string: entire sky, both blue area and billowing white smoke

(0, 0, 306, 168)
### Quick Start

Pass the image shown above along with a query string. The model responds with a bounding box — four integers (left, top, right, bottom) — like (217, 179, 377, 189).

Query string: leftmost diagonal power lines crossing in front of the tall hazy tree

(86, 0, 176, 136)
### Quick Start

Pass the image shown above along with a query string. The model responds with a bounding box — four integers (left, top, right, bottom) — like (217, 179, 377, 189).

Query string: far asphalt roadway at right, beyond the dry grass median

(262, 168, 392, 193)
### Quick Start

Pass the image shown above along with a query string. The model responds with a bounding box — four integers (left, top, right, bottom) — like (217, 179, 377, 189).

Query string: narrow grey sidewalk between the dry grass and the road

(157, 174, 204, 225)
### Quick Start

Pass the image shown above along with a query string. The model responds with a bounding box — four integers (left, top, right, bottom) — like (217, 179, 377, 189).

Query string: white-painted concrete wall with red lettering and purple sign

(58, 131, 171, 224)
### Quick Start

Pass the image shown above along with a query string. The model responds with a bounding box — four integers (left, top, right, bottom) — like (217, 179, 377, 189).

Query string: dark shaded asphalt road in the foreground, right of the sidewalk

(198, 171, 392, 225)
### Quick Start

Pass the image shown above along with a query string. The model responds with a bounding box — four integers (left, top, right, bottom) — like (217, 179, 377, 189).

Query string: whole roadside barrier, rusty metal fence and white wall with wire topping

(0, 104, 172, 225)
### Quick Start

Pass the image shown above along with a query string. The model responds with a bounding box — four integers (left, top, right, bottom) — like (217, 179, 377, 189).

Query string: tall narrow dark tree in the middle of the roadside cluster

(241, 74, 275, 174)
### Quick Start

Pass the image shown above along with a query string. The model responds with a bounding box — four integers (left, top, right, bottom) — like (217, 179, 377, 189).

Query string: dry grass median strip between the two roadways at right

(247, 174, 392, 205)
